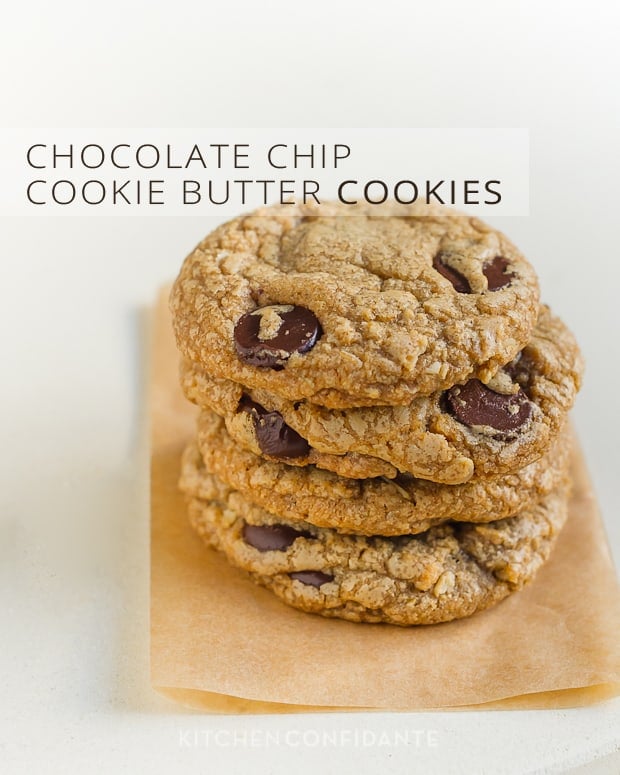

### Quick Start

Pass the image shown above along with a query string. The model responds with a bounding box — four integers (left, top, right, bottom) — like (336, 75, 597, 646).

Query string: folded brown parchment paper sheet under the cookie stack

(150, 289, 620, 713)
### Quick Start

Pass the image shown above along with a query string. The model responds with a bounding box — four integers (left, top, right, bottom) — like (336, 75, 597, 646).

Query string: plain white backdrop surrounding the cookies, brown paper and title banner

(0, 0, 620, 773)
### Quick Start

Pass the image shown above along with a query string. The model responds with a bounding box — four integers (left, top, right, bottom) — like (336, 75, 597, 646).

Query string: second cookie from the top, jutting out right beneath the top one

(181, 306, 583, 484)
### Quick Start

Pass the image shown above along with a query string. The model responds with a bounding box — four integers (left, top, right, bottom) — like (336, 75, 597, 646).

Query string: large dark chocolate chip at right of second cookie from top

(445, 379, 532, 432)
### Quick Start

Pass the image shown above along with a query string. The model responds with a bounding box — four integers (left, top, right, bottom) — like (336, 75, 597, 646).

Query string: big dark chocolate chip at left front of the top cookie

(234, 304, 323, 369)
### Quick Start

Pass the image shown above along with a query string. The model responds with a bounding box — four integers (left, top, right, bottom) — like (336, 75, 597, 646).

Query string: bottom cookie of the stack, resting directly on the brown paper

(189, 483, 567, 625)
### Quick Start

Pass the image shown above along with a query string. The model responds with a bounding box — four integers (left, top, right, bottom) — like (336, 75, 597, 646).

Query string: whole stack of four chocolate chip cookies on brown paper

(171, 205, 582, 625)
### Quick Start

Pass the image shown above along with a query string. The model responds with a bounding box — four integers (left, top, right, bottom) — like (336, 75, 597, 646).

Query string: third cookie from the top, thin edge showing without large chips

(181, 422, 570, 535)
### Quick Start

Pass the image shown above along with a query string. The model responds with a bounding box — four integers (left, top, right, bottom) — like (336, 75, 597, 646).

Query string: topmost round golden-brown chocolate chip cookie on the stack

(171, 200, 538, 408)
